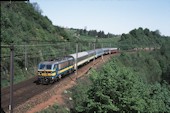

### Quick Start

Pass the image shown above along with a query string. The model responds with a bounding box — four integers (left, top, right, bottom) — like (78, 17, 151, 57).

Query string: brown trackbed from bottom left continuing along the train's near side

(1, 54, 114, 112)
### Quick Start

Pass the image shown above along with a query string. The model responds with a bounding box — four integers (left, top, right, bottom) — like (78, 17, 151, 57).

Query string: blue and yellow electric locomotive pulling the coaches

(38, 56, 74, 84)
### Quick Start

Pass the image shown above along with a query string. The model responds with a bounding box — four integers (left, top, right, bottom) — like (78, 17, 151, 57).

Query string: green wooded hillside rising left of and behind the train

(1, 1, 117, 87)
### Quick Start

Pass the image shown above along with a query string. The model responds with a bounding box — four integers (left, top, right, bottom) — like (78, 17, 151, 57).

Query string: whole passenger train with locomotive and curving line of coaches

(37, 48, 119, 84)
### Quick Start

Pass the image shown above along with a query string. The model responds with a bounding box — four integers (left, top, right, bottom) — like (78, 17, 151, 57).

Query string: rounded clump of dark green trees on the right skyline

(119, 27, 166, 50)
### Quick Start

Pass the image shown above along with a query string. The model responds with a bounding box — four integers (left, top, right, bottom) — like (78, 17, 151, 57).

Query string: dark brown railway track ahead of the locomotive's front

(1, 77, 51, 111)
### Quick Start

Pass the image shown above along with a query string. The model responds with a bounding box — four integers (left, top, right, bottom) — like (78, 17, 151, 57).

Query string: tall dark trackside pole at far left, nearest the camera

(9, 45, 14, 113)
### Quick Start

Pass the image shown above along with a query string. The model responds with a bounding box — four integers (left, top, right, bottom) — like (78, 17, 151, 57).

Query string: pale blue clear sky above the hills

(30, 0, 170, 36)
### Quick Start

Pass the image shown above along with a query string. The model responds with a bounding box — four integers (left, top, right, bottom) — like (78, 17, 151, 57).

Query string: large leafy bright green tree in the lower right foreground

(73, 54, 170, 113)
